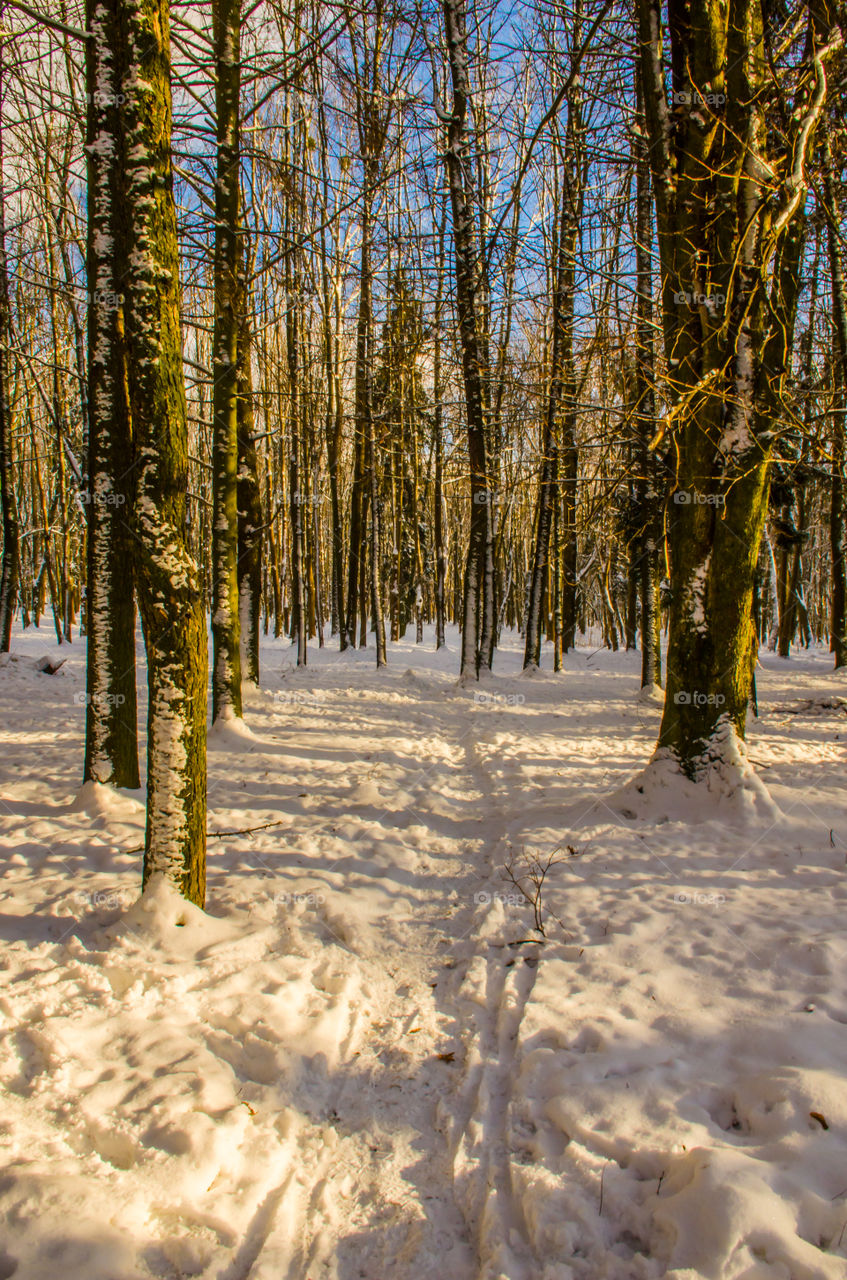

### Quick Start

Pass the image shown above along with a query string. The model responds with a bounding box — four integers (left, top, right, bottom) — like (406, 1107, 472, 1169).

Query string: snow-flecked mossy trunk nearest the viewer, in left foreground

(109, 0, 209, 906)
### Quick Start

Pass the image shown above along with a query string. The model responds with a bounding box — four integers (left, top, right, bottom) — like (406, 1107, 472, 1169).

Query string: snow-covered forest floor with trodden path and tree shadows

(0, 628, 847, 1280)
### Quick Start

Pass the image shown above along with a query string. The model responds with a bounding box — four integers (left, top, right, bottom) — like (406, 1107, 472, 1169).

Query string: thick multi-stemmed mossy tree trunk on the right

(637, 0, 827, 778)
